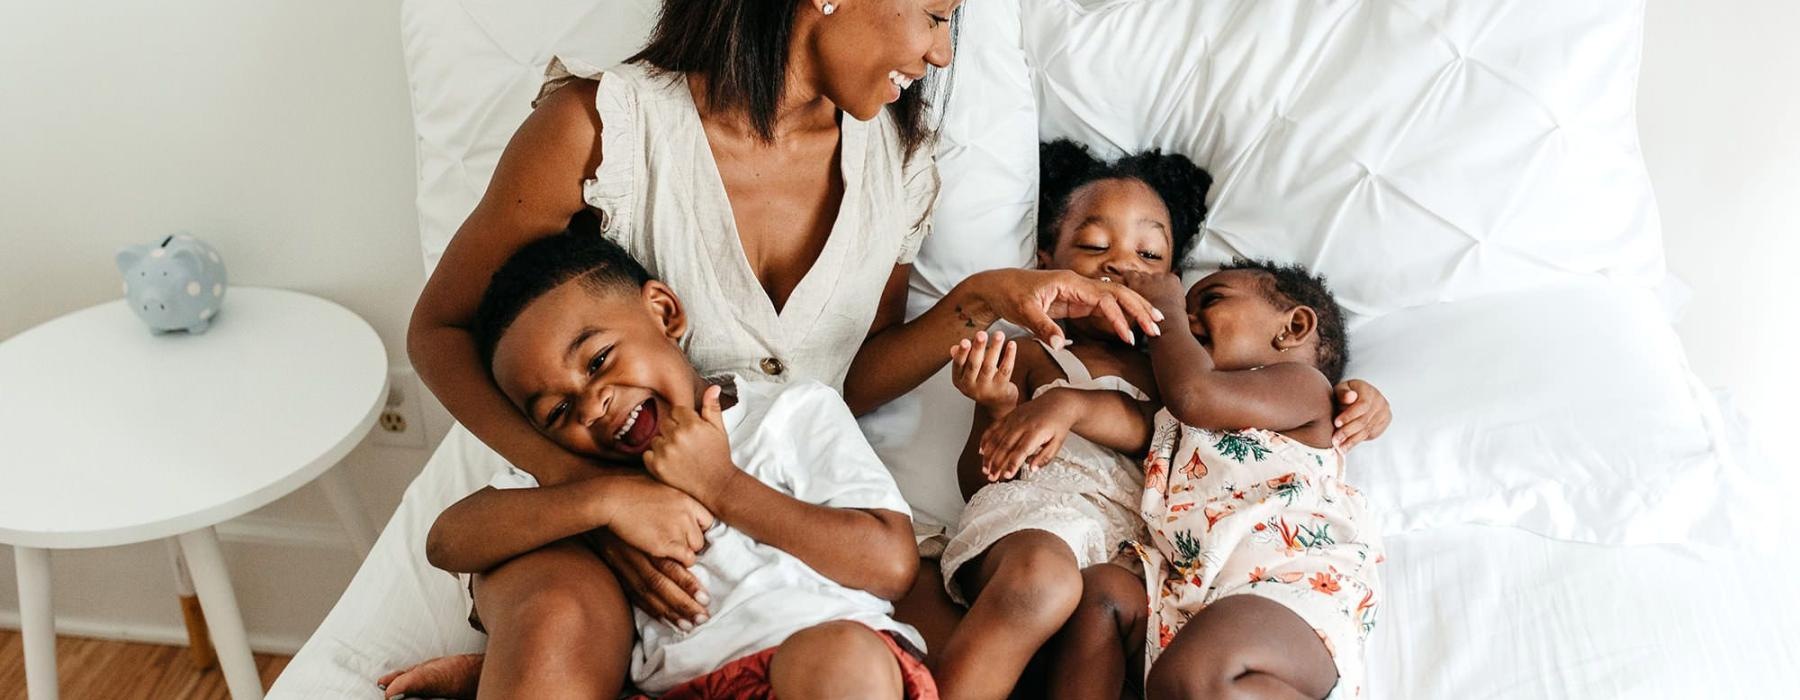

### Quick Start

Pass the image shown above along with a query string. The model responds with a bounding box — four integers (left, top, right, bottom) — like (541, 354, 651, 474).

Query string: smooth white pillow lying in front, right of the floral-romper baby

(1348, 281, 1764, 545)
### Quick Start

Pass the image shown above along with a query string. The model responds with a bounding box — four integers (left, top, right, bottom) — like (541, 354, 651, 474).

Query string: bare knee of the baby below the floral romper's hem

(1145, 596, 1337, 700)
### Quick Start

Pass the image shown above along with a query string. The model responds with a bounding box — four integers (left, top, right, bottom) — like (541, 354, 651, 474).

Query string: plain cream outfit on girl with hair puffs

(943, 342, 1148, 605)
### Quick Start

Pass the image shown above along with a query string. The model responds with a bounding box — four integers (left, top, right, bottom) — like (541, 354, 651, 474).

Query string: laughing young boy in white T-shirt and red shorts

(389, 219, 936, 698)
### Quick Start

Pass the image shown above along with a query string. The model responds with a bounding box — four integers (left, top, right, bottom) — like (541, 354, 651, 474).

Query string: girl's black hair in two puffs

(1037, 139, 1213, 259)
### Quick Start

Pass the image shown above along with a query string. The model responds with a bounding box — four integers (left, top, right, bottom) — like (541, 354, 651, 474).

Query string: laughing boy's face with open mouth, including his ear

(493, 281, 702, 461)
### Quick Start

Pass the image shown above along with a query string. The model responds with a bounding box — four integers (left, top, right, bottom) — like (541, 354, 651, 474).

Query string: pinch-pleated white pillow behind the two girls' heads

(1022, 0, 1663, 315)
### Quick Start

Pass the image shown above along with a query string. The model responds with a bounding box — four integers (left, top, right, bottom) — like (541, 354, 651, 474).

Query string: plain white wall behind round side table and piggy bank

(0, 0, 446, 650)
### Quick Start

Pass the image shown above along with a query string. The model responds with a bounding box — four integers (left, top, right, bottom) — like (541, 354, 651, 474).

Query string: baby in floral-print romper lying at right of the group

(983, 261, 1382, 698)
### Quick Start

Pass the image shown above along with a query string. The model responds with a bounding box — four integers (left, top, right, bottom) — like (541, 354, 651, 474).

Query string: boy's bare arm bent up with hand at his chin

(644, 387, 918, 601)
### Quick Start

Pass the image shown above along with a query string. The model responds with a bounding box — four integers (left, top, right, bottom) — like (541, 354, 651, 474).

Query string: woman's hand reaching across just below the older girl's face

(965, 270, 1163, 347)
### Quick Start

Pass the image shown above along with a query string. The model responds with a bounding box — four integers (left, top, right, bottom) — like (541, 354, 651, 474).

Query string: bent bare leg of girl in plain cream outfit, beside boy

(934, 529, 1082, 700)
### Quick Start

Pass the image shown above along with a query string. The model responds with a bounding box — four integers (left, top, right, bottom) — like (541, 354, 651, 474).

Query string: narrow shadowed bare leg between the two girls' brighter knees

(1046, 563, 1150, 700)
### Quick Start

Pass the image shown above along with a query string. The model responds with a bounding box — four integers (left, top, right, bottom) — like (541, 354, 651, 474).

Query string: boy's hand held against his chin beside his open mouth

(644, 385, 743, 513)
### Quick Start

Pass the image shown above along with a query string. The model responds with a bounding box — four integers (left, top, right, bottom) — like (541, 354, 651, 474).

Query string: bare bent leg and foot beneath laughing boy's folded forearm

(383, 540, 637, 698)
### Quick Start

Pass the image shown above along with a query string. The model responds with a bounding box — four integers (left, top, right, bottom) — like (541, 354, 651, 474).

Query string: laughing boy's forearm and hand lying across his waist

(425, 475, 713, 574)
